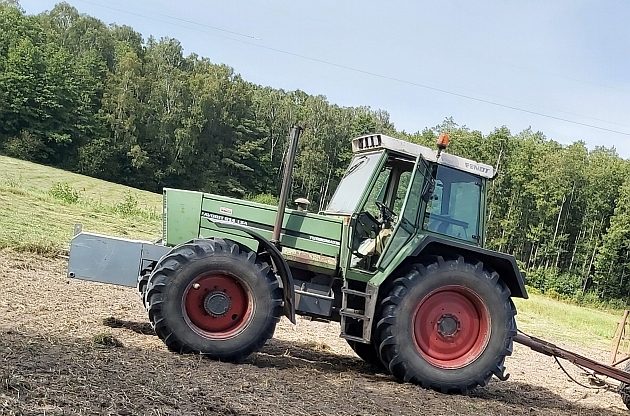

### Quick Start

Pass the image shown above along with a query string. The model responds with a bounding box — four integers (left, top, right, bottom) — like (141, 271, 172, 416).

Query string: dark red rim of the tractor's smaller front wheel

(183, 273, 253, 339)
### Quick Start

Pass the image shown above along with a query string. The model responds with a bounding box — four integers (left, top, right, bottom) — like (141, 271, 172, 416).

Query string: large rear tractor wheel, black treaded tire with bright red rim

(376, 256, 516, 394)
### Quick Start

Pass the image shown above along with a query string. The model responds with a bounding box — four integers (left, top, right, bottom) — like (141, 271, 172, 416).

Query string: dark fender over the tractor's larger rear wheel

(413, 235, 528, 299)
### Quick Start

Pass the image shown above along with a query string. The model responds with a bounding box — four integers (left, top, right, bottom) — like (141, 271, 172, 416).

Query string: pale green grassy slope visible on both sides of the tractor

(0, 156, 621, 349)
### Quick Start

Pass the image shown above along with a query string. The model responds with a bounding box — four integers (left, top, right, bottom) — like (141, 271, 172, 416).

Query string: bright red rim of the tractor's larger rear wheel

(412, 285, 491, 369)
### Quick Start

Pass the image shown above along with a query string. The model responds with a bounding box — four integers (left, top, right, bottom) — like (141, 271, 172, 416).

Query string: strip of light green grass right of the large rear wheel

(514, 294, 623, 350)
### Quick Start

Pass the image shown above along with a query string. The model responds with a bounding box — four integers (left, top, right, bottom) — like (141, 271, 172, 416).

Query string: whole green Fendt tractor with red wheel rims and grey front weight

(68, 128, 527, 393)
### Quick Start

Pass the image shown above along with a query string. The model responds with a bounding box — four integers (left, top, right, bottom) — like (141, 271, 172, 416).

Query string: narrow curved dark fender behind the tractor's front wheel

(207, 218, 296, 324)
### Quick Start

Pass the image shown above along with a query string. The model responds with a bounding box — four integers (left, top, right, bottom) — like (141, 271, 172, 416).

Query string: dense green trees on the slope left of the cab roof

(0, 2, 393, 206)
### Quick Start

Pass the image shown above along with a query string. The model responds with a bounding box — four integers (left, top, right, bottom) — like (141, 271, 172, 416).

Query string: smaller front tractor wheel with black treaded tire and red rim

(146, 239, 283, 362)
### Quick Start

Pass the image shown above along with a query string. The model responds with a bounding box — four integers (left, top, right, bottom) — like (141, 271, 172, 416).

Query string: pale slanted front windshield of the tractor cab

(326, 152, 383, 214)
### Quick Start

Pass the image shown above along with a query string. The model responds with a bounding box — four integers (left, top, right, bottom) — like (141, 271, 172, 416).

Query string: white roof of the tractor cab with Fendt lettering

(352, 134, 494, 179)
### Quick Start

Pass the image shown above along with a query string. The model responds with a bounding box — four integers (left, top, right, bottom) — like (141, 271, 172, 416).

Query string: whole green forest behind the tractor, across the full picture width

(0, 0, 630, 306)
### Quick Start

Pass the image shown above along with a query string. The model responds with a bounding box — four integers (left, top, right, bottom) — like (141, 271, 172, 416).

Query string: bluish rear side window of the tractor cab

(423, 165, 481, 243)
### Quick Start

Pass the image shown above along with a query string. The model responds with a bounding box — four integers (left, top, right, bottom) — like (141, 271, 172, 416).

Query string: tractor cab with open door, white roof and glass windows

(325, 135, 493, 272)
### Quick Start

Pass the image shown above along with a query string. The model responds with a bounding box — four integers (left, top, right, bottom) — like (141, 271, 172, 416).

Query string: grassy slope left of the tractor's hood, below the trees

(0, 156, 162, 254)
